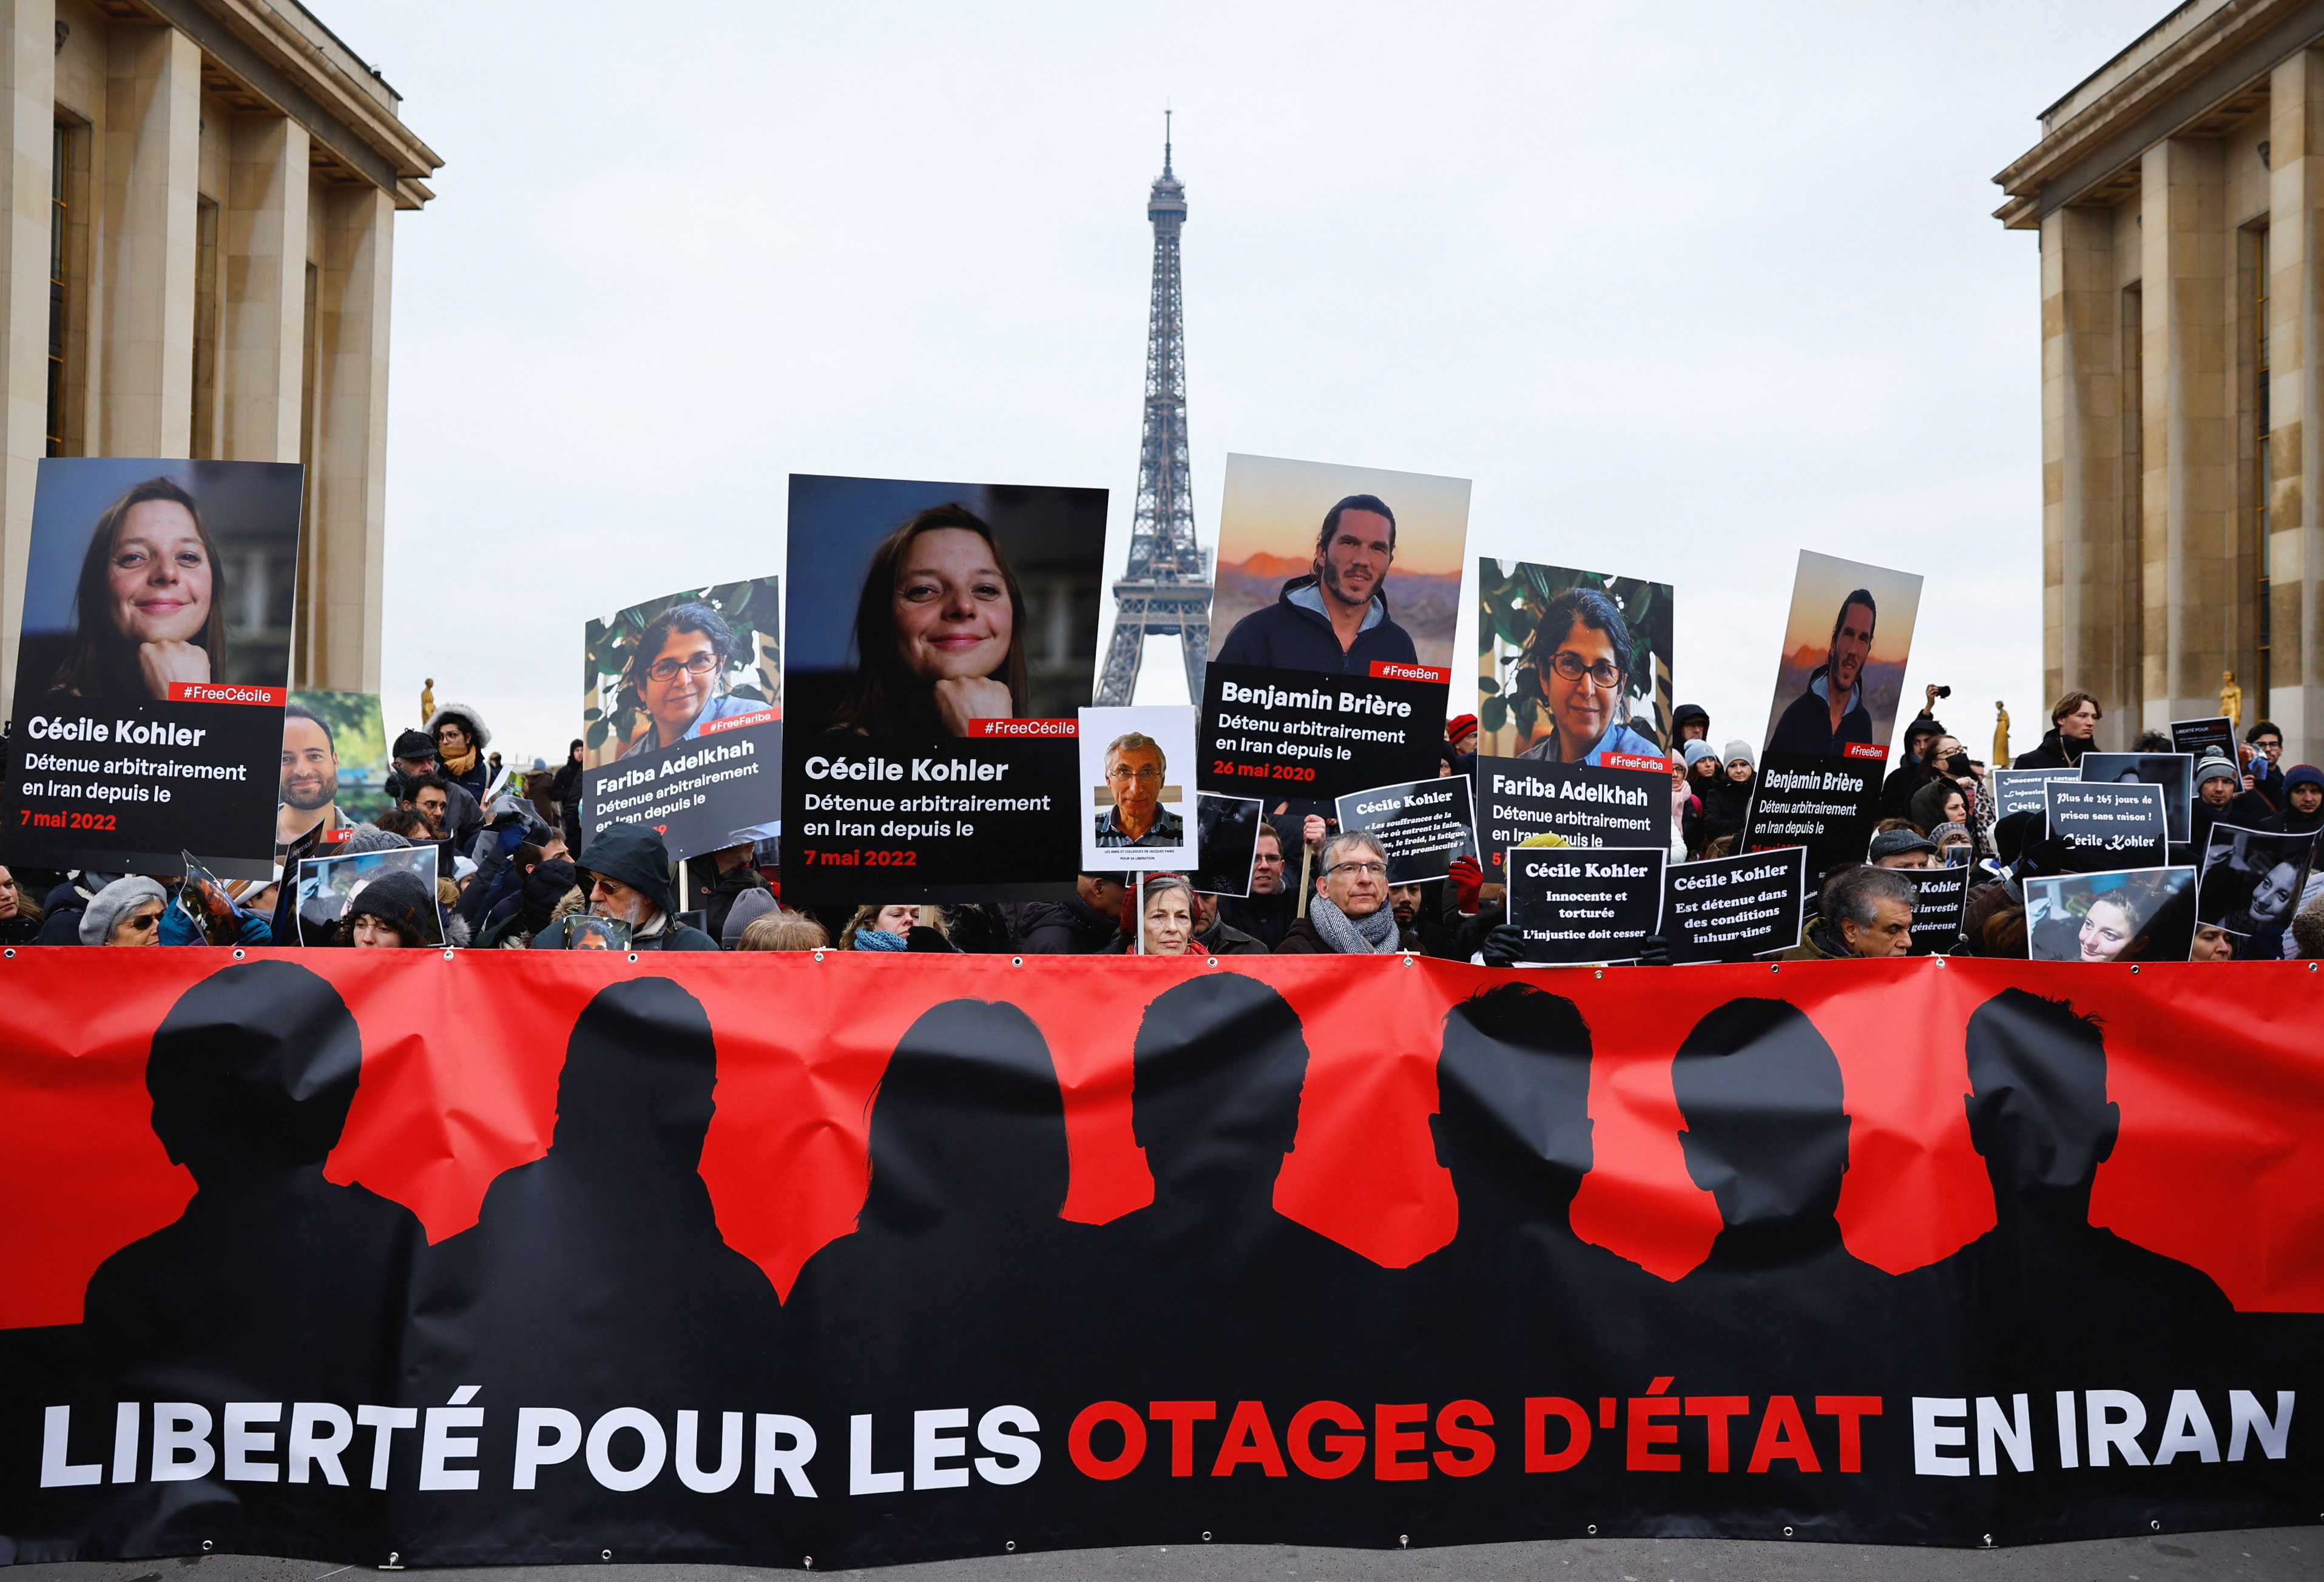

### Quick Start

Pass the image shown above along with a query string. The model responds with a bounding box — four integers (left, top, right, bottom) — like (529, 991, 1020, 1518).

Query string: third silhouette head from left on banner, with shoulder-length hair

(857, 999, 1072, 1229)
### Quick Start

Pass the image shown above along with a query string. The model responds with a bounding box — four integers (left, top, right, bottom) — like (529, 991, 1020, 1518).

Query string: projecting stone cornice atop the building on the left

(104, 0, 444, 209)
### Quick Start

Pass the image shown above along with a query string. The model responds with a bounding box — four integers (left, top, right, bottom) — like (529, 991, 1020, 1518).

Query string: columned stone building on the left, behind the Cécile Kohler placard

(0, 0, 442, 715)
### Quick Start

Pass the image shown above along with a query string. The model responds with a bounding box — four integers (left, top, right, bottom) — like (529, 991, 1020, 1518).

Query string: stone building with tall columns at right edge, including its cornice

(1994, 0, 2324, 764)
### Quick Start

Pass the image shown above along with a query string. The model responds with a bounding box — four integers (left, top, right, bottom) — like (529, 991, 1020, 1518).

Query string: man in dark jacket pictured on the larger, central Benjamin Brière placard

(1218, 495, 1417, 676)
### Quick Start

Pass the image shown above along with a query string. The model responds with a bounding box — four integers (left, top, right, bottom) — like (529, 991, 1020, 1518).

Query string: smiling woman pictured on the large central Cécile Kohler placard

(832, 504, 1030, 737)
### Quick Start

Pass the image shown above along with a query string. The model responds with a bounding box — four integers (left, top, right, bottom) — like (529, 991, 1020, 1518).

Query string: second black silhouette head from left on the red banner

(551, 978, 718, 1180)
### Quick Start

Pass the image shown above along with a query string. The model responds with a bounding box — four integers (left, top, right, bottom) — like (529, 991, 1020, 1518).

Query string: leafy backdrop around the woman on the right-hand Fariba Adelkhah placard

(1476, 558, 1671, 757)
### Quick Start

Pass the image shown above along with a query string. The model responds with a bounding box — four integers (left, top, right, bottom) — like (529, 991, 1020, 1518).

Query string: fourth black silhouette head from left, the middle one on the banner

(1129, 973, 1306, 1201)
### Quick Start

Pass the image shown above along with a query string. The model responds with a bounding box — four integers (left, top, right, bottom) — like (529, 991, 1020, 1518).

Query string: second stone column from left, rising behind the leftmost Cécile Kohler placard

(93, 23, 202, 455)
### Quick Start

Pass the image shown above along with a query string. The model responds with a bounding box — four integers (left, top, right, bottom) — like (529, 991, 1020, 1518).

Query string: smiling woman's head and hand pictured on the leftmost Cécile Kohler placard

(49, 479, 226, 701)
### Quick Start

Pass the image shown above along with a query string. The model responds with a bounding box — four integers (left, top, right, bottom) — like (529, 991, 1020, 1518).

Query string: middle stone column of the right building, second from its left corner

(2140, 137, 2240, 729)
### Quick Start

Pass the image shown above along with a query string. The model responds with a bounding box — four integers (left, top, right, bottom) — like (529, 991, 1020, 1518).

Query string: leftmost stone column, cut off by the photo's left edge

(0, 0, 56, 718)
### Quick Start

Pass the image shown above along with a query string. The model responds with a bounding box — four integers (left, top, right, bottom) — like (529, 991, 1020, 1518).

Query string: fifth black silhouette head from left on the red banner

(1429, 982, 1592, 1217)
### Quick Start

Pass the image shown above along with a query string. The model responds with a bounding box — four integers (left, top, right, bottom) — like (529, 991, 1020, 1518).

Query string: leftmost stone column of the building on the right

(2013, 198, 2138, 737)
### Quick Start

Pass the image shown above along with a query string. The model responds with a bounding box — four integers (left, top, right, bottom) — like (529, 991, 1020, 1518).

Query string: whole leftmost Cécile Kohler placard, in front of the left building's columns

(0, 458, 305, 878)
